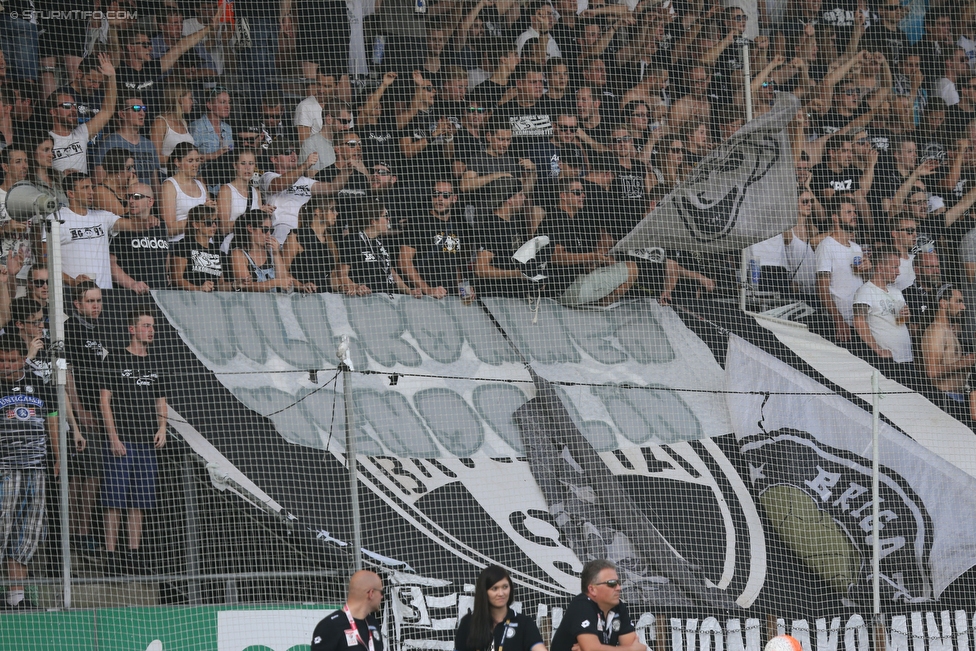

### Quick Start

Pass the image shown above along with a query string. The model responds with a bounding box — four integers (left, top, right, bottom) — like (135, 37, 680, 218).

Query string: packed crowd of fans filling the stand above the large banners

(0, 0, 976, 603)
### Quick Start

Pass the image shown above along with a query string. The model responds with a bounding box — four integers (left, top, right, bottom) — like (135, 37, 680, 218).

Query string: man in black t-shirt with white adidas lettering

(109, 183, 169, 294)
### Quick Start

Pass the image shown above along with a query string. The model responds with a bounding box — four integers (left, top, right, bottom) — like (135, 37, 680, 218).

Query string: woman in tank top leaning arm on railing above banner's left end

(230, 210, 315, 292)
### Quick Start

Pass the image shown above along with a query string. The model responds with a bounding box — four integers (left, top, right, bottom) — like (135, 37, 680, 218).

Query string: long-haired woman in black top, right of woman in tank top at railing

(281, 197, 339, 292)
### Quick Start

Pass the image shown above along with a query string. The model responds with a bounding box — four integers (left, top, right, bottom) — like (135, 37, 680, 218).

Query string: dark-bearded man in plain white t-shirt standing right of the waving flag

(816, 195, 871, 345)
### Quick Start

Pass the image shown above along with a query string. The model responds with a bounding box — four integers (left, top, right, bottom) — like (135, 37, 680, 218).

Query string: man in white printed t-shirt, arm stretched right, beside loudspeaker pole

(57, 172, 145, 289)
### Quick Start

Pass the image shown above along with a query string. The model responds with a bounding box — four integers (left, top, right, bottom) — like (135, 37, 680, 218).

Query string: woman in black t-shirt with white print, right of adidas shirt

(170, 205, 229, 292)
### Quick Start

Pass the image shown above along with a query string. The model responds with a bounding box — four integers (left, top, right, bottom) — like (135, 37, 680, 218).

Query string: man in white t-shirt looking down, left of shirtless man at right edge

(854, 247, 912, 382)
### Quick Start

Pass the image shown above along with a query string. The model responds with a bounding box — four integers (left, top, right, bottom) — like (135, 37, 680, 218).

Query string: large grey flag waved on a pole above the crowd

(612, 93, 800, 253)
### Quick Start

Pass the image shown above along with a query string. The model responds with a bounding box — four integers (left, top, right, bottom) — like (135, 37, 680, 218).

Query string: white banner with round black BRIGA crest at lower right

(726, 336, 976, 604)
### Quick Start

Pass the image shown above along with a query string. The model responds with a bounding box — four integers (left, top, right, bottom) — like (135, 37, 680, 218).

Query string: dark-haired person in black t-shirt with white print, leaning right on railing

(334, 202, 423, 298)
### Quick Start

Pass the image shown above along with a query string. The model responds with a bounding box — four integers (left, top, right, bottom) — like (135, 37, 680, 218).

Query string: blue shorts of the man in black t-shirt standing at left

(102, 443, 156, 509)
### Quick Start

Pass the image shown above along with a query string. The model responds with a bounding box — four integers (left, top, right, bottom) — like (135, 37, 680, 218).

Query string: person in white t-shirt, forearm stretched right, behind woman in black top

(258, 140, 350, 244)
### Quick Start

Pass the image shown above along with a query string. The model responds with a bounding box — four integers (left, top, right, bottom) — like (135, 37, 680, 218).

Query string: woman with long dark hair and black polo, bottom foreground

(454, 565, 546, 651)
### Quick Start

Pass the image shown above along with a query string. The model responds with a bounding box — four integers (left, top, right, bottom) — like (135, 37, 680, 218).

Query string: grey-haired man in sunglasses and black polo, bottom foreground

(549, 559, 647, 651)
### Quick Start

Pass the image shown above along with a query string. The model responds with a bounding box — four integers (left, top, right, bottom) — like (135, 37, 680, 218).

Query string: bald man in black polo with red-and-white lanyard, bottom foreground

(311, 570, 383, 651)
